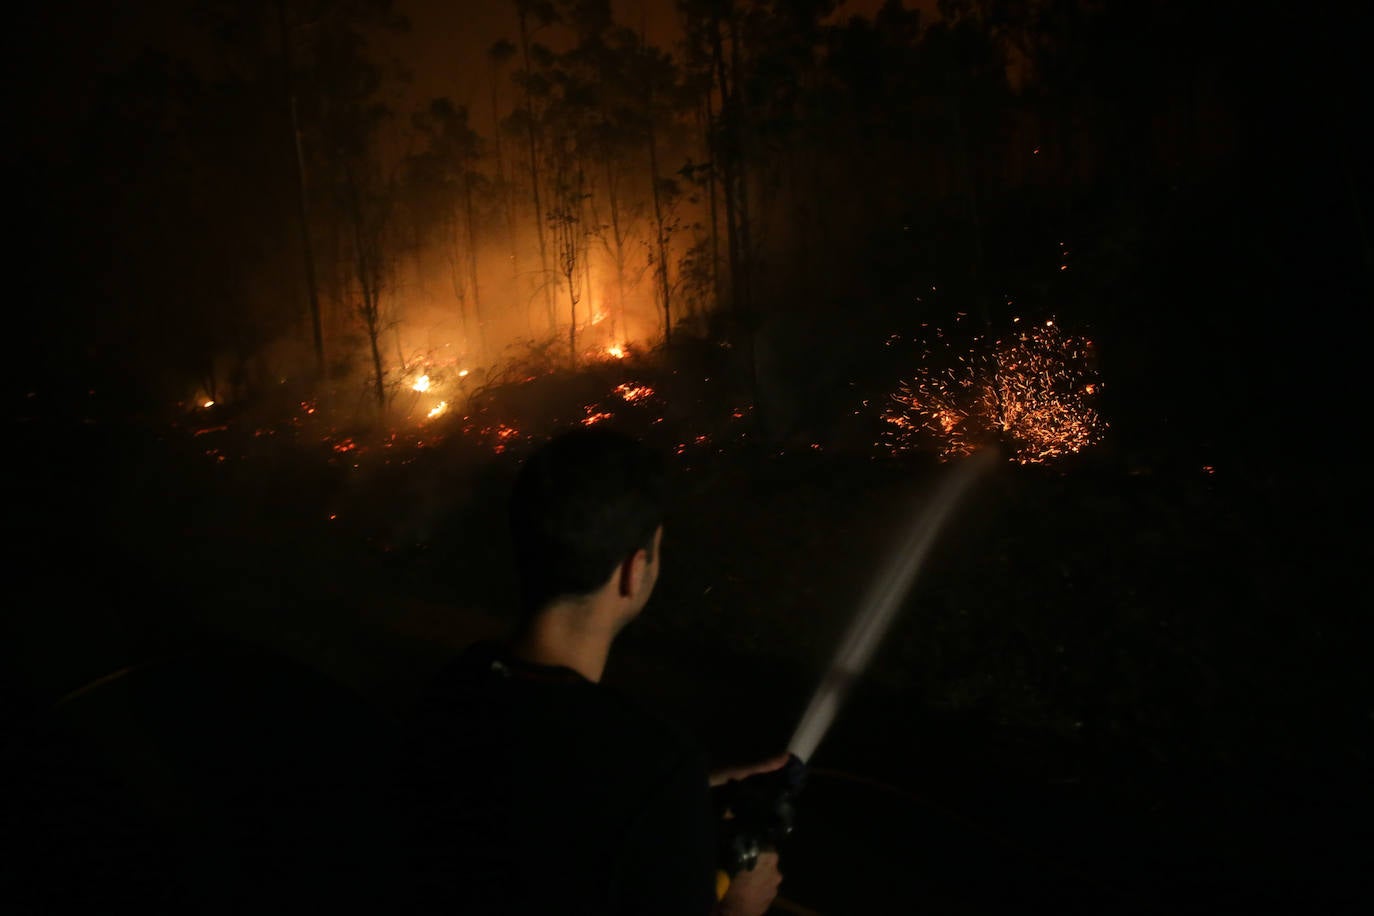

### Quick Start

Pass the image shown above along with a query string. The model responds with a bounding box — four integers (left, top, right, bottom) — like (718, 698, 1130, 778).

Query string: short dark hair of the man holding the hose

(510, 427, 666, 615)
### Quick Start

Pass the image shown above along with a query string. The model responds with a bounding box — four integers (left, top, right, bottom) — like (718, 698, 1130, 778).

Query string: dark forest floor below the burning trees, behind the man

(5, 324, 1371, 916)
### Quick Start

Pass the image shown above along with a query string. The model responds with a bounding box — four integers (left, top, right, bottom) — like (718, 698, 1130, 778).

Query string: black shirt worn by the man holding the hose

(407, 643, 716, 916)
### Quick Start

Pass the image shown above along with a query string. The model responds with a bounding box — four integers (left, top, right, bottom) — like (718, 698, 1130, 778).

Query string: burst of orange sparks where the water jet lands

(882, 320, 1106, 464)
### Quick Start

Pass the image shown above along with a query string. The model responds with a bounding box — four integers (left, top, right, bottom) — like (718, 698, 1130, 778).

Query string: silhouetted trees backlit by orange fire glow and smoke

(8, 0, 1370, 425)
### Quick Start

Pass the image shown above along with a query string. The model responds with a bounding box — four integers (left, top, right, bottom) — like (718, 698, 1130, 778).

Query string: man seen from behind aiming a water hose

(398, 428, 786, 916)
